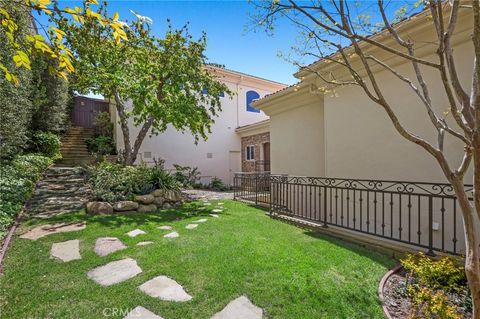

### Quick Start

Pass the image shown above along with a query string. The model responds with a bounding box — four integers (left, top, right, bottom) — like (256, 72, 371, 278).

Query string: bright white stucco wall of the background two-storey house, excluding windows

(115, 71, 279, 183)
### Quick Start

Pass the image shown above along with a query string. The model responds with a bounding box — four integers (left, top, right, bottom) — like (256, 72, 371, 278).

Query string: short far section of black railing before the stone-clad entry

(233, 172, 271, 207)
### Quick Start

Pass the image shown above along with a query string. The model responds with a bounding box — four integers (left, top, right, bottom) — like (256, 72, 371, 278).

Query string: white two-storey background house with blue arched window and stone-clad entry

(111, 66, 286, 184)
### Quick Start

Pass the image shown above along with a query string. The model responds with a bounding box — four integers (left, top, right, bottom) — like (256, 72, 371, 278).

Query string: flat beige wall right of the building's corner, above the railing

(322, 39, 473, 182)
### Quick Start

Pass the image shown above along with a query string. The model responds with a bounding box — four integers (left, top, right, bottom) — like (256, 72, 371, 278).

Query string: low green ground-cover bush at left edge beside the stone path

(0, 154, 53, 238)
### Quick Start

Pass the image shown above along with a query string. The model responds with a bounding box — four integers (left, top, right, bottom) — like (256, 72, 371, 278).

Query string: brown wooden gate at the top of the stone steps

(72, 96, 108, 128)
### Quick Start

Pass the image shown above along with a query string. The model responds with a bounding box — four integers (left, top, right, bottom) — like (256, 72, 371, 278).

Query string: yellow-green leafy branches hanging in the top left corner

(0, 0, 126, 85)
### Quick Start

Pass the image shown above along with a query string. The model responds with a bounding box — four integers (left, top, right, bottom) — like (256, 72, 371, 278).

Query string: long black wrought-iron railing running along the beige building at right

(236, 174, 471, 255)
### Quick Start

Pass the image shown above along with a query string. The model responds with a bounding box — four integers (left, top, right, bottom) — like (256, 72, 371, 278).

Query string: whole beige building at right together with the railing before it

(244, 10, 480, 254)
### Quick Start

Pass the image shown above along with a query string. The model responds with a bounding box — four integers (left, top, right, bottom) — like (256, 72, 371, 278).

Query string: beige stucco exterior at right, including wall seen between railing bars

(253, 7, 473, 255)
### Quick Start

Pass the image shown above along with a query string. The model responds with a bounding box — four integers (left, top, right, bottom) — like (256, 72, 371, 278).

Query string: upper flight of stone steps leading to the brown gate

(57, 126, 94, 167)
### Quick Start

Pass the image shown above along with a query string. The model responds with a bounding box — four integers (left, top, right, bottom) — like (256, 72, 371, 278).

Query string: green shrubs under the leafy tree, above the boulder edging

(88, 162, 179, 202)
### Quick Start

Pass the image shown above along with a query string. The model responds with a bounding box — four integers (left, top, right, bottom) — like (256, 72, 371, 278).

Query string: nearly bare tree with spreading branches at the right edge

(255, 0, 480, 318)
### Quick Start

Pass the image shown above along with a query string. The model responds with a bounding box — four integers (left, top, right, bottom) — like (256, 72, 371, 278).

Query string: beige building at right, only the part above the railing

(253, 10, 474, 182)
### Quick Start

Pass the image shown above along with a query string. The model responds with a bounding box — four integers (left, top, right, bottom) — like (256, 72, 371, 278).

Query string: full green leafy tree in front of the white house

(55, 6, 230, 165)
